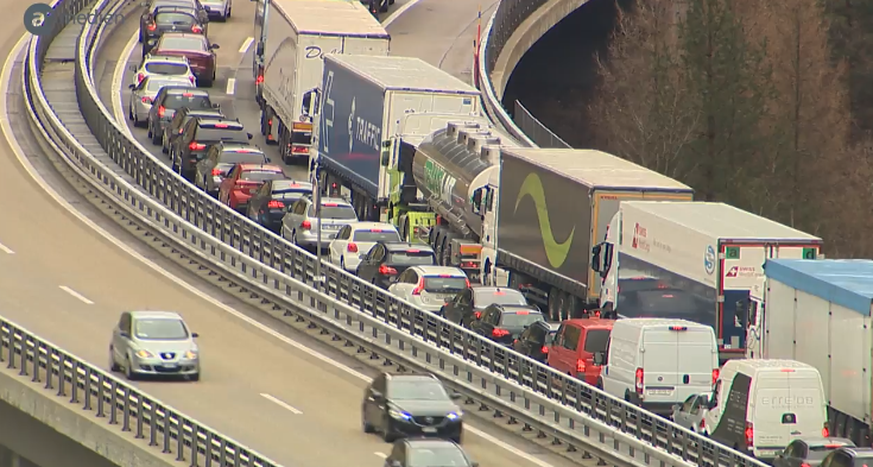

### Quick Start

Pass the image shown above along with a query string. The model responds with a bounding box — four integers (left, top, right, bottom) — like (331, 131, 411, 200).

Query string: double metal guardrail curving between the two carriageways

(18, 0, 764, 467)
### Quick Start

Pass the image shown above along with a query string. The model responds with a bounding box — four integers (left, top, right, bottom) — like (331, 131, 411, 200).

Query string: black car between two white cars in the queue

(358, 242, 436, 289)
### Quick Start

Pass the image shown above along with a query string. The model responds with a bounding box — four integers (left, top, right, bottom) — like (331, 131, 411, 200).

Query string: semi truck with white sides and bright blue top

(749, 259, 873, 446)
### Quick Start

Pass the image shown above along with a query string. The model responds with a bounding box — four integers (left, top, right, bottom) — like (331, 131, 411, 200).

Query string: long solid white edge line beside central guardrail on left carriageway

(0, 33, 554, 467)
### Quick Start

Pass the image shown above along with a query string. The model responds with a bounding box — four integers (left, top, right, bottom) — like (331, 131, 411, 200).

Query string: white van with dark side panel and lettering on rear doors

(704, 362, 830, 460)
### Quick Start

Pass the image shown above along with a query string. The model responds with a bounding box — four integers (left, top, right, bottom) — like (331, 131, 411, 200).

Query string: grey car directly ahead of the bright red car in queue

(195, 142, 270, 198)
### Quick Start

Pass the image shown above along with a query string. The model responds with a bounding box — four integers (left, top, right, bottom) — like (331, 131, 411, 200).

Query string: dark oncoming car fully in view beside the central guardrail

(361, 373, 464, 443)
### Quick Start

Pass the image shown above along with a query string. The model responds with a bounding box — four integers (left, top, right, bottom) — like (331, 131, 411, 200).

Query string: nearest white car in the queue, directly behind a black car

(388, 266, 470, 314)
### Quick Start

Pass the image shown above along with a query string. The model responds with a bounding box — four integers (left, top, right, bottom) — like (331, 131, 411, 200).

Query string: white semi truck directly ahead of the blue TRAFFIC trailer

(252, 0, 390, 164)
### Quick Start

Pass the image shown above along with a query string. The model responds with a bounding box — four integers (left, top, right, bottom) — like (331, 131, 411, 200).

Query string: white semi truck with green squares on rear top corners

(592, 201, 822, 361)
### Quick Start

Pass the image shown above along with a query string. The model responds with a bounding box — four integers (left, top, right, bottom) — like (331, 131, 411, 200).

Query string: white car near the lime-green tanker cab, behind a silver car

(327, 222, 400, 274)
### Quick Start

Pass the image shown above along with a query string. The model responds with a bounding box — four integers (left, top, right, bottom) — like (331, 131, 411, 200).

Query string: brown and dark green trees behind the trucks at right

(544, 0, 873, 258)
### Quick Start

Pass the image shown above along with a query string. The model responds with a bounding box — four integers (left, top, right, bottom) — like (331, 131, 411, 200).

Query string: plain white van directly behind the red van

(595, 318, 718, 415)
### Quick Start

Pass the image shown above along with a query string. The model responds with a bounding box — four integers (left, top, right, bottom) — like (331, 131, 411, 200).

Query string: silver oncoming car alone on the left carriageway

(109, 311, 200, 381)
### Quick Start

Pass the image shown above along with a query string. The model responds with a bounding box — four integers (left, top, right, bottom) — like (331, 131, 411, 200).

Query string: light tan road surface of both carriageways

(0, 0, 570, 467)
